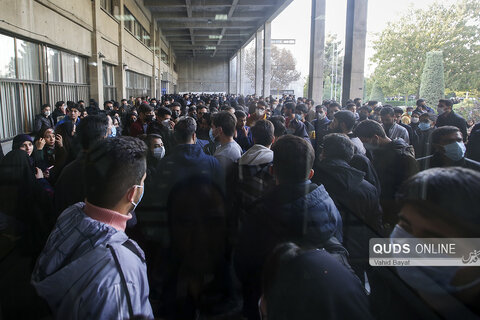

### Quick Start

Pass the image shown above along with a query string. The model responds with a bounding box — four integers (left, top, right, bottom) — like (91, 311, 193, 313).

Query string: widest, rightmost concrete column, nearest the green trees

(342, 0, 368, 105)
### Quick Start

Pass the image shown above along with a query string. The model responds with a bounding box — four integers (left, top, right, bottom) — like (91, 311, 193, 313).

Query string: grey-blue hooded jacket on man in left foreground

(32, 202, 153, 319)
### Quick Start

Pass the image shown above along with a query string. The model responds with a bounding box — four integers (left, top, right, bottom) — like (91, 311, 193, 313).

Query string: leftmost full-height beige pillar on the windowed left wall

(88, 0, 103, 108)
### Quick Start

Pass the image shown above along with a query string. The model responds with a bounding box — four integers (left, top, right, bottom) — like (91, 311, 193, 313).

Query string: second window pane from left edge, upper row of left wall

(16, 39, 40, 80)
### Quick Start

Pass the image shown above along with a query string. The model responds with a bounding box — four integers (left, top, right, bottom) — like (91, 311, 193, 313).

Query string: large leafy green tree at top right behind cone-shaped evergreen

(373, 0, 480, 95)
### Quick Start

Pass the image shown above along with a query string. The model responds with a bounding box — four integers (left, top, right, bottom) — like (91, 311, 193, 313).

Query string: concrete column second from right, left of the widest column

(308, 0, 326, 104)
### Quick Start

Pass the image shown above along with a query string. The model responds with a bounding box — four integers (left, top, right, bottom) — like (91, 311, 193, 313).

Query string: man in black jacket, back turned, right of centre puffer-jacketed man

(312, 133, 383, 280)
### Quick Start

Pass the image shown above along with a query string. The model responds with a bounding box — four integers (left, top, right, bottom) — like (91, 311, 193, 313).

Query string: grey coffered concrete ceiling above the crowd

(144, 0, 292, 58)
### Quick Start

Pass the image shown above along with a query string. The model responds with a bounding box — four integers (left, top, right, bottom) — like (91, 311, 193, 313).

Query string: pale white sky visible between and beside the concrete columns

(272, 0, 456, 77)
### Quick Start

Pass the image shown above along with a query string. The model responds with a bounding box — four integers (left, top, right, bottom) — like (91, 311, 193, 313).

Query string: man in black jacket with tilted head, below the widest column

(353, 120, 418, 231)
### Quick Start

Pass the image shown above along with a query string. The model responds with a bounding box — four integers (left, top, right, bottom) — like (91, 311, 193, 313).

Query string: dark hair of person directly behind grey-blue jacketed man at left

(77, 115, 108, 150)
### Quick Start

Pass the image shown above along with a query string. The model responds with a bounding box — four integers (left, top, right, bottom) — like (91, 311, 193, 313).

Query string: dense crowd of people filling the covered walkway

(0, 94, 480, 319)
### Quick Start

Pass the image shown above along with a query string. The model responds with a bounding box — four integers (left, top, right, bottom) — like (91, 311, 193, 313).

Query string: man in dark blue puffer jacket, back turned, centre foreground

(234, 135, 342, 319)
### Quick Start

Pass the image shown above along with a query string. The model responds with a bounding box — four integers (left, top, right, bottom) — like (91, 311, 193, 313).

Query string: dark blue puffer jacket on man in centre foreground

(234, 181, 343, 319)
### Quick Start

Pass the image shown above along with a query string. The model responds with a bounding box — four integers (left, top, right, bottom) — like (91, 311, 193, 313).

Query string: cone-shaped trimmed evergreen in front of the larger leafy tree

(420, 51, 445, 105)
